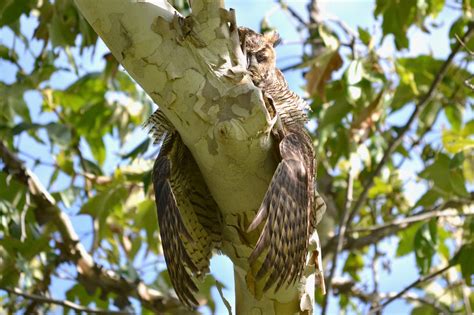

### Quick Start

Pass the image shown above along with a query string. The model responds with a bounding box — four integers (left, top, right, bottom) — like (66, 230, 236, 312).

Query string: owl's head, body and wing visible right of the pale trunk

(239, 28, 326, 291)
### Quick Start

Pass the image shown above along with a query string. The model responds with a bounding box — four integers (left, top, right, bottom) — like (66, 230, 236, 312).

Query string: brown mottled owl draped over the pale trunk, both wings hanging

(146, 28, 325, 306)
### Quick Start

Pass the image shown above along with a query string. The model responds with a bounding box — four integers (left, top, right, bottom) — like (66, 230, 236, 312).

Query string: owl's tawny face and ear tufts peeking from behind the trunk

(239, 27, 280, 79)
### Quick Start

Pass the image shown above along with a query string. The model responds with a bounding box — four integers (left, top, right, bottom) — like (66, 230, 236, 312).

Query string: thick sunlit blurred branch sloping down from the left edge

(0, 141, 181, 312)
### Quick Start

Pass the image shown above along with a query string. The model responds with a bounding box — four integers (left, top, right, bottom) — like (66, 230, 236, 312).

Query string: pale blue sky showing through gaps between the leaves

(0, 0, 466, 314)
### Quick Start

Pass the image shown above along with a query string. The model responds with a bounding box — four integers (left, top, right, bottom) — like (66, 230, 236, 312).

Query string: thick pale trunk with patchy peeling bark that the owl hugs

(76, 0, 314, 314)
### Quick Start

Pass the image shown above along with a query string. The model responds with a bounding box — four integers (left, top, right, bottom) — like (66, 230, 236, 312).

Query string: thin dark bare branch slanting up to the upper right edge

(349, 24, 474, 227)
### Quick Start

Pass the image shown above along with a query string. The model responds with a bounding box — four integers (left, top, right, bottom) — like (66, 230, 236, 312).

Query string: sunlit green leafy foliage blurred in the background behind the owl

(0, 0, 474, 314)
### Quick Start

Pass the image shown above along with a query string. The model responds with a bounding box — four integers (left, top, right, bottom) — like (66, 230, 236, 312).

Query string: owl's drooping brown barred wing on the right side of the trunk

(248, 132, 314, 291)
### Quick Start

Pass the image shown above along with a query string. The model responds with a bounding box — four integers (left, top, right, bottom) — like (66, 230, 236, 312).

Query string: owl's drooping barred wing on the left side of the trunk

(149, 111, 222, 306)
